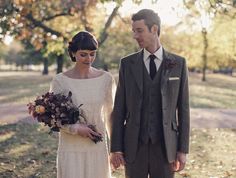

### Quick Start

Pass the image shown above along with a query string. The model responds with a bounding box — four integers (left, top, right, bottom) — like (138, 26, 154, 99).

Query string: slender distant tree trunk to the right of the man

(202, 28, 208, 82)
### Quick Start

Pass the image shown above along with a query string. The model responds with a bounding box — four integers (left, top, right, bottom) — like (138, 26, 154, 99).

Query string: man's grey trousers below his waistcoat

(125, 142, 174, 178)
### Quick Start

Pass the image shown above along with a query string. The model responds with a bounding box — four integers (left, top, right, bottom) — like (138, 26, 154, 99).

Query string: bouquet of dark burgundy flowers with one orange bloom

(27, 91, 102, 143)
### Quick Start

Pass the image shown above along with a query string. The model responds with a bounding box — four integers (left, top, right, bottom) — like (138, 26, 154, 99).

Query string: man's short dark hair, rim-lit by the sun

(132, 9, 161, 36)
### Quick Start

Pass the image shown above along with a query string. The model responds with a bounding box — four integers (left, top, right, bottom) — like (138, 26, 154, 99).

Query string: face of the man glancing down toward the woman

(132, 20, 154, 49)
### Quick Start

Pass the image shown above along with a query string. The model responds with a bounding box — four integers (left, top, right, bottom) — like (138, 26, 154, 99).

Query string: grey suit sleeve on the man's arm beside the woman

(110, 60, 126, 152)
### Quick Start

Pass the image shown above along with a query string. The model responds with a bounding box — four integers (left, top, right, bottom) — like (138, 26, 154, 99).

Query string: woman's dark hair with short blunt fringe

(68, 31, 98, 62)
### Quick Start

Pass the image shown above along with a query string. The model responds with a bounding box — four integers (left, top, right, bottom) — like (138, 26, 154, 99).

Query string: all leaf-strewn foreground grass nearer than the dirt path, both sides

(0, 123, 236, 178)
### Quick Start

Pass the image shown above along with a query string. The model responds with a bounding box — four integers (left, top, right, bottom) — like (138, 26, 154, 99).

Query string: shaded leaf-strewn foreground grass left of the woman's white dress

(0, 123, 57, 178)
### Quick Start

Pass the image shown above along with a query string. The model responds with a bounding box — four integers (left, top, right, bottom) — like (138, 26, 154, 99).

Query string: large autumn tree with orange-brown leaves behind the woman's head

(0, 0, 122, 72)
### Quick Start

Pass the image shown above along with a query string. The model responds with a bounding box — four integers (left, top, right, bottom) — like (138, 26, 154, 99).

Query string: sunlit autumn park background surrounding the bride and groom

(0, 0, 236, 178)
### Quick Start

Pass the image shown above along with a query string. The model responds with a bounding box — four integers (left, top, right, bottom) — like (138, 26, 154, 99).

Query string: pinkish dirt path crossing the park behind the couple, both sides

(0, 104, 236, 128)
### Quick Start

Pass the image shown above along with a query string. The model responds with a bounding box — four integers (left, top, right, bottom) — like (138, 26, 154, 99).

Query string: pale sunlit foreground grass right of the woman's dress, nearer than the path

(114, 128, 236, 178)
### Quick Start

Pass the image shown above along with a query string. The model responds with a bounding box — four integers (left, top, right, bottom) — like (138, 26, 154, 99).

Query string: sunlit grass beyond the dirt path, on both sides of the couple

(0, 72, 236, 109)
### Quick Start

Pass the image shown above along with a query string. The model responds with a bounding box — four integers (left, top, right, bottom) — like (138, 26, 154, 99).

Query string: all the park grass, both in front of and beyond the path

(0, 72, 236, 178)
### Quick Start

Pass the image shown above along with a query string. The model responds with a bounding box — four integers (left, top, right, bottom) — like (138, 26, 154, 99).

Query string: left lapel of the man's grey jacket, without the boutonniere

(131, 50, 143, 93)
